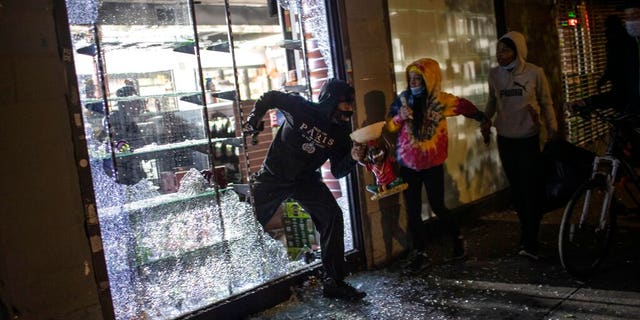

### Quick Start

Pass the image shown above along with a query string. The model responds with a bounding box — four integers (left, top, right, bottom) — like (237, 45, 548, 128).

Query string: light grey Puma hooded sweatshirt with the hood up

(485, 31, 558, 138)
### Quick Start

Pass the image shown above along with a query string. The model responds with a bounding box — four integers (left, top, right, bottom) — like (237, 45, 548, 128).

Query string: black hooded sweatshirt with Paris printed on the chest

(252, 79, 356, 182)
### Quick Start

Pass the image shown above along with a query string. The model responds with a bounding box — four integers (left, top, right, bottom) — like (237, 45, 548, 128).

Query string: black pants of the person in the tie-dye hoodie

(400, 165, 460, 251)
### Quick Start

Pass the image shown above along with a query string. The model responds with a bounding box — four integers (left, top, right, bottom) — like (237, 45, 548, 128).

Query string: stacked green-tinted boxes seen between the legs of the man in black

(283, 200, 318, 259)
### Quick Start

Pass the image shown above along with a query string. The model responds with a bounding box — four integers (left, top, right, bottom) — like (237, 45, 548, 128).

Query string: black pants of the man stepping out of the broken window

(252, 170, 345, 281)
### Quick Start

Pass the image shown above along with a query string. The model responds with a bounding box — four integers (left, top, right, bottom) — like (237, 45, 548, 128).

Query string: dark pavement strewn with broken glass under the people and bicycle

(247, 206, 640, 319)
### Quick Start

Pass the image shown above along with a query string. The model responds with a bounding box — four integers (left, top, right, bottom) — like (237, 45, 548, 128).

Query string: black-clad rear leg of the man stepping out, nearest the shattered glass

(251, 171, 295, 227)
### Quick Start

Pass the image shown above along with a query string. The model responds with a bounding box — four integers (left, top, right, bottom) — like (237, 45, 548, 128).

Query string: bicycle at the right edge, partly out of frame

(558, 110, 640, 278)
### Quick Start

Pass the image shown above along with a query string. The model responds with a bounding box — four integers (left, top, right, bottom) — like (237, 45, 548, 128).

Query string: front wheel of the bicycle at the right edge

(558, 175, 616, 278)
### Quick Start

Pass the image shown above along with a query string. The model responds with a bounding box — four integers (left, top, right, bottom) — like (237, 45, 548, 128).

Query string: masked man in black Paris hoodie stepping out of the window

(245, 79, 366, 300)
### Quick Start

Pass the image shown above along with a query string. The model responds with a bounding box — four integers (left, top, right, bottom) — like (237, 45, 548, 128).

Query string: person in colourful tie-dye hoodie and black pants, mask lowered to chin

(387, 58, 488, 274)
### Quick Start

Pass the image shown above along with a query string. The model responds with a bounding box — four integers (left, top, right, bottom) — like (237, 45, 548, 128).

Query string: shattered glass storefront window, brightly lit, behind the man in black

(66, 0, 353, 319)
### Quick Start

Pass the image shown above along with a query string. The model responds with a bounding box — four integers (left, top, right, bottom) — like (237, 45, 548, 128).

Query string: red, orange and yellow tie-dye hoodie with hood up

(387, 58, 485, 170)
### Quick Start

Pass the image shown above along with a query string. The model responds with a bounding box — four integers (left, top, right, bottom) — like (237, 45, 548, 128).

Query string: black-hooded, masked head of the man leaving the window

(318, 79, 355, 122)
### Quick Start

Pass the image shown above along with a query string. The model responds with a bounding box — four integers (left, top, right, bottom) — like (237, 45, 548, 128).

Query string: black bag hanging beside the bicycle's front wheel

(542, 140, 595, 212)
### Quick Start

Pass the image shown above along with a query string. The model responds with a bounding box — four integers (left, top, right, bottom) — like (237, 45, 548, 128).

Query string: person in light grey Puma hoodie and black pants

(483, 31, 558, 259)
